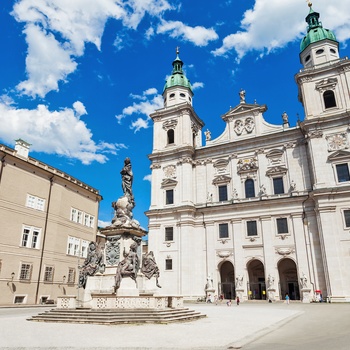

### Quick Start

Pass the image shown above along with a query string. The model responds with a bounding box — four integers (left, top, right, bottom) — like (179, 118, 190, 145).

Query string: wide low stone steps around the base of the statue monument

(28, 308, 206, 325)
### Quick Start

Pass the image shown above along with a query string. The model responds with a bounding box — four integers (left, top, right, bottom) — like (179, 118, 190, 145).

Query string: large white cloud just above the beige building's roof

(0, 98, 126, 164)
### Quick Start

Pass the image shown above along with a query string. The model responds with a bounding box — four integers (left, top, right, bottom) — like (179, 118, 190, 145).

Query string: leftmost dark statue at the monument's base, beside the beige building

(78, 242, 105, 289)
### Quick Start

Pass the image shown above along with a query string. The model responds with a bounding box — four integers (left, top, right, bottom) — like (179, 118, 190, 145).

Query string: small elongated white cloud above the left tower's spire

(157, 20, 219, 46)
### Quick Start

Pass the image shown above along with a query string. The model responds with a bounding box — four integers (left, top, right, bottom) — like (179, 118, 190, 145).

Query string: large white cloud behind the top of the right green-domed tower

(212, 0, 350, 61)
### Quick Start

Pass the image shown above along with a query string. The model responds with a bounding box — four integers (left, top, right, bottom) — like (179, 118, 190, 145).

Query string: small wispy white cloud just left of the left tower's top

(115, 88, 163, 133)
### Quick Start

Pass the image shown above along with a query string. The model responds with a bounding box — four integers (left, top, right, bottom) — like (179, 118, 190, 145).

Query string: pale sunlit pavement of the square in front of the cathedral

(0, 302, 350, 350)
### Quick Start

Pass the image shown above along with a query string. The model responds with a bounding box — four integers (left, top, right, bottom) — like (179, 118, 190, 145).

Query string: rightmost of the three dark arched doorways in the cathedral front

(278, 258, 300, 300)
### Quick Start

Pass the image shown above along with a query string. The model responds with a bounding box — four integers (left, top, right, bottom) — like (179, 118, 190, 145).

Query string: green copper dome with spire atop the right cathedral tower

(300, 4, 337, 52)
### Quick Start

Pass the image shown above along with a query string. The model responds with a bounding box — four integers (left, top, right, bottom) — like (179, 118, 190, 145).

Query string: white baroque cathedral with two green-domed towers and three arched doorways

(146, 4, 350, 302)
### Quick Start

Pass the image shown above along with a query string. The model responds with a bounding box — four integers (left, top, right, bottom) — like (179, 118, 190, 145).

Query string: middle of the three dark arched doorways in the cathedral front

(247, 259, 266, 300)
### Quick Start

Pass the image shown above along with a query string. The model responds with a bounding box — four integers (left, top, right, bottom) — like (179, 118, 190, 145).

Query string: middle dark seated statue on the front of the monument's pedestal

(114, 242, 140, 292)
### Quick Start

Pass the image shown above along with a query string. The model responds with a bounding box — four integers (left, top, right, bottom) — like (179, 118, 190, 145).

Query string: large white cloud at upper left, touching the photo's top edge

(12, 0, 174, 97)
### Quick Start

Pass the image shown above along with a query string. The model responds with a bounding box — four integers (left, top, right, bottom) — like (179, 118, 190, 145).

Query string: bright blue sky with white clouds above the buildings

(0, 0, 350, 228)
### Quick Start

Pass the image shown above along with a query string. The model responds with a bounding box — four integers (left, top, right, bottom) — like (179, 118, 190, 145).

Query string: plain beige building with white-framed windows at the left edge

(0, 140, 102, 305)
